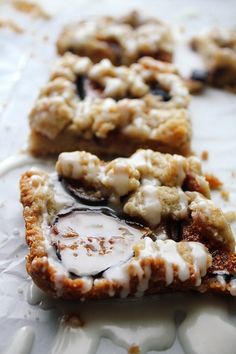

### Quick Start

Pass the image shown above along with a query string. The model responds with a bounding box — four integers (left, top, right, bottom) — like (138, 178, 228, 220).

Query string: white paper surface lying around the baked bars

(0, 0, 236, 354)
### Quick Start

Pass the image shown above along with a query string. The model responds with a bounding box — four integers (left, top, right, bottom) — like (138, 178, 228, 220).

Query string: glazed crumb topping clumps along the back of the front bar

(56, 150, 234, 249)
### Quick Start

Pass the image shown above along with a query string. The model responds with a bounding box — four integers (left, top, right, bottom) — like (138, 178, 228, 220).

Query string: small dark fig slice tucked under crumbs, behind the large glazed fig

(61, 178, 106, 205)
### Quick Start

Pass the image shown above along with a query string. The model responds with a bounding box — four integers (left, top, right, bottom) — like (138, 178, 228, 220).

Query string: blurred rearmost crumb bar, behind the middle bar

(57, 11, 174, 65)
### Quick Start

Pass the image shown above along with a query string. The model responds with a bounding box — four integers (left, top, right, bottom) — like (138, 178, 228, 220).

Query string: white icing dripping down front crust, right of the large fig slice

(103, 237, 209, 297)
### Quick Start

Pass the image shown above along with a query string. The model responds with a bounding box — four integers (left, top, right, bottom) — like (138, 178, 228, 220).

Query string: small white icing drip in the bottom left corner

(4, 326, 34, 354)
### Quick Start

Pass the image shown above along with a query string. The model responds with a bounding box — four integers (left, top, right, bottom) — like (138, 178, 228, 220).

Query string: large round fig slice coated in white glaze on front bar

(50, 210, 146, 276)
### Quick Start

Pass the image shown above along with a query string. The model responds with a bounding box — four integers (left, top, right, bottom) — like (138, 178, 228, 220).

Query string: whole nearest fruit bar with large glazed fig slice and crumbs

(20, 150, 236, 299)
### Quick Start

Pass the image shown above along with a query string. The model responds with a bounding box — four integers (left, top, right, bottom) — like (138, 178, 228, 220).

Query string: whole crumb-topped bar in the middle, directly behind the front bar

(29, 53, 191, 156)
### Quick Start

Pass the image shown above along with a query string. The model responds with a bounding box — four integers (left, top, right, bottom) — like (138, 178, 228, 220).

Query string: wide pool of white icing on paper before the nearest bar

(44, 294, 236, 354)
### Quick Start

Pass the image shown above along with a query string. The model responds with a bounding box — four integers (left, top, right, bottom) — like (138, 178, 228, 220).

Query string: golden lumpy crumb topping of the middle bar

(30, 53, 190, 140)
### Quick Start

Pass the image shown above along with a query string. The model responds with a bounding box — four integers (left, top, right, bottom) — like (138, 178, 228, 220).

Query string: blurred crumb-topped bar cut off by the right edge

(191, 29, 236, 90)
